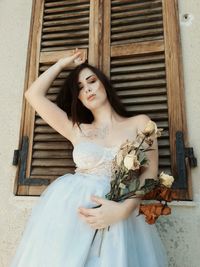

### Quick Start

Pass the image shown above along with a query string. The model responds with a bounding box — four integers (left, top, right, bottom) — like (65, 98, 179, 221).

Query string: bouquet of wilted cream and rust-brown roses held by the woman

(92, 120, 177, 255)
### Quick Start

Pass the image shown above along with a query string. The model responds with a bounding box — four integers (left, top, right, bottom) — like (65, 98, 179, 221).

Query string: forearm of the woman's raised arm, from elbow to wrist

(25, 62, 62, 96)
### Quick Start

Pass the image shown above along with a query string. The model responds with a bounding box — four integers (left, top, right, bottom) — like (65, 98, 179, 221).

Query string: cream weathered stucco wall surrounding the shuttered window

(0, 0, 200, 267)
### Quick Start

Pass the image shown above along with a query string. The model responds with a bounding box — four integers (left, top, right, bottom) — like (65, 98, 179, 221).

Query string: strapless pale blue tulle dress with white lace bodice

(10, 141, 168, 267)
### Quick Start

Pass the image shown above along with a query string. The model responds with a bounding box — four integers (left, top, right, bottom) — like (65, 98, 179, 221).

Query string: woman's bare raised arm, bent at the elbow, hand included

(25, 50, 83, 141)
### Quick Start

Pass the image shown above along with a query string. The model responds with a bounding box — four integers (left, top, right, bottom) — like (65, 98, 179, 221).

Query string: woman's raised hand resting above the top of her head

(58, 48, 86, 69)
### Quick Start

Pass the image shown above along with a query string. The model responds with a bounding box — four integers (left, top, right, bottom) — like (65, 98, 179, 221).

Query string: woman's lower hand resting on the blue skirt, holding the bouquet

(78, 196, 124, 229)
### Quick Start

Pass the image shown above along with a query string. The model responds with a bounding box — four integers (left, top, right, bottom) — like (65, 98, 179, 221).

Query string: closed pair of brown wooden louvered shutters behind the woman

(15, 0, 195, 200)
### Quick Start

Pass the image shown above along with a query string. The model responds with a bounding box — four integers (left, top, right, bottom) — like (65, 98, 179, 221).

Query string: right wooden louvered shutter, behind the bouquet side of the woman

(101, 0, 195, 200)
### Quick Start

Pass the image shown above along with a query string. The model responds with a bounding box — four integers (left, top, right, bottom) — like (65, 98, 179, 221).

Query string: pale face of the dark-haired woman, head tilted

(78, 68, 107, 110)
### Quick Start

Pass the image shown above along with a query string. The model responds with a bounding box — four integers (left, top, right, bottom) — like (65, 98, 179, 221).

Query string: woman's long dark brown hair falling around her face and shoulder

(56, 62, 130, 125)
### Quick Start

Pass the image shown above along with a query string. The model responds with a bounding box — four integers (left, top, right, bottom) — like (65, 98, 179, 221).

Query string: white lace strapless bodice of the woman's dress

(73, 141, 119, 176)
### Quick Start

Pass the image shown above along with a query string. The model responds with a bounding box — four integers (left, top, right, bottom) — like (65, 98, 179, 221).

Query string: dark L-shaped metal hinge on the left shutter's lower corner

(12, 136, 50, 186)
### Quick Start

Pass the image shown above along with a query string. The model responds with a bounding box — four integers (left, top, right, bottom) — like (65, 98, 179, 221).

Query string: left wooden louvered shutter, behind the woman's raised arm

(15, 0, 93, 195)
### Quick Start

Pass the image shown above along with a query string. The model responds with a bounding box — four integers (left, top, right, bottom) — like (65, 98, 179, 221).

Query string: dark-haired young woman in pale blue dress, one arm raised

(11, 50, 167, 267)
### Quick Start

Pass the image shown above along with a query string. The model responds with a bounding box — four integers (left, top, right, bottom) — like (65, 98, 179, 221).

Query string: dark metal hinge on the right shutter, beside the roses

(173, 131, 197, 189)
